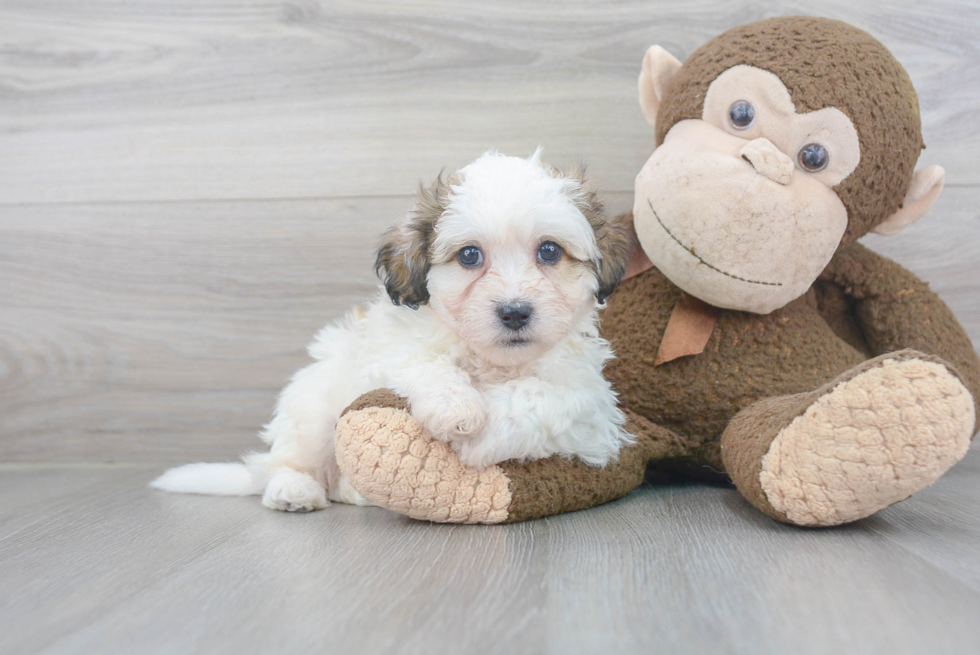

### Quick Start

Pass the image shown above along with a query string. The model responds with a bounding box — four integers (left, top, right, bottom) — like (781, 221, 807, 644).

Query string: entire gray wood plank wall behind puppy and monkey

(0, 0, 980, 462)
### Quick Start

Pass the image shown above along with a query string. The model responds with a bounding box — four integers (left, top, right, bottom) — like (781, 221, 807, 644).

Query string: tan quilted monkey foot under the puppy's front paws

(336, 392, 511, 523)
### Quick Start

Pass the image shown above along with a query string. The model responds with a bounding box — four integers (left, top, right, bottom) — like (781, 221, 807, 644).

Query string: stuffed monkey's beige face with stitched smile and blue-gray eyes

(633, 65, 861, 314)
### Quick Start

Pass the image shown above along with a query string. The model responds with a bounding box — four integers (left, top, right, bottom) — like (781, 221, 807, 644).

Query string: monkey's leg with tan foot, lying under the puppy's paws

(337, 390, 689, 523)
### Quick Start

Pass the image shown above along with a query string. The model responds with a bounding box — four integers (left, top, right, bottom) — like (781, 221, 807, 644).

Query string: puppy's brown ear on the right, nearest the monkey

(571, 166, 634, 303)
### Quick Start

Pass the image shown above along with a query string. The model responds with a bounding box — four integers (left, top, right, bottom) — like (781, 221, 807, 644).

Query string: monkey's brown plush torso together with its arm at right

(602, 241, 980, 470)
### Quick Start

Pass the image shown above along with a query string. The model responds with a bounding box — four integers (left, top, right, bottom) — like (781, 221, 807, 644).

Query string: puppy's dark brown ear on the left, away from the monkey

(374, 174, 449, 309)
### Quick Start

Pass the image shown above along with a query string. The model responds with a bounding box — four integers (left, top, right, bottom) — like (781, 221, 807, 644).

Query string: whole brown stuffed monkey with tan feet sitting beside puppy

(337, 17, 980, 526)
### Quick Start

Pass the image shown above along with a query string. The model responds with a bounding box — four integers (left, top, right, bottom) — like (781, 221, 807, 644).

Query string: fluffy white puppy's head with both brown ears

(377, 150, 630, 366)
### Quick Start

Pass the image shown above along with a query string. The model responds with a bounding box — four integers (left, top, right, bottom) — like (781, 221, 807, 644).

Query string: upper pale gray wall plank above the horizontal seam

(0, 0, 980, 203)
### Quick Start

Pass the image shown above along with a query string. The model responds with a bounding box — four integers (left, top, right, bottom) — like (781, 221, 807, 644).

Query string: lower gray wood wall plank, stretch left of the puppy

(0, 198, 400, 461)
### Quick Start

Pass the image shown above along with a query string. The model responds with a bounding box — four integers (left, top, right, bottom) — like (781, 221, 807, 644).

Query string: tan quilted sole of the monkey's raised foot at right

(759, 351, 975, 526)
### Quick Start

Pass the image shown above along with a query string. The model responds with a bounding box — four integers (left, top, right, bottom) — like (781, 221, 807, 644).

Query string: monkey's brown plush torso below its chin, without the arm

(602, 256, 867, 470)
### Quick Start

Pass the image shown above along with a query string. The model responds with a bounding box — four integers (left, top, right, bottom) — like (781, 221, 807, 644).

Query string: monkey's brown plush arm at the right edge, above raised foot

(820, 243, 980, 408)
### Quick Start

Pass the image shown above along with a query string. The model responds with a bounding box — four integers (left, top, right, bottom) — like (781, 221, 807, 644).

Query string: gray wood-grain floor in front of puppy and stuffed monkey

(0, 451, 980, 655)
